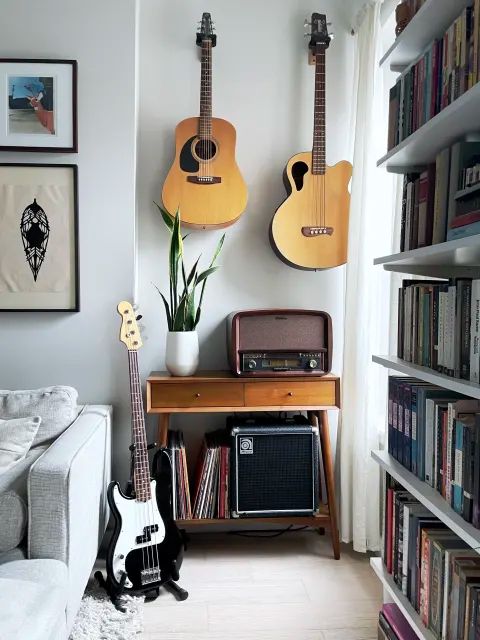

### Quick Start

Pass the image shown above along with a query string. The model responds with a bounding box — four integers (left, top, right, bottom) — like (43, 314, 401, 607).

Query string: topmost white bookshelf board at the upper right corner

(380, 0, 471, 71)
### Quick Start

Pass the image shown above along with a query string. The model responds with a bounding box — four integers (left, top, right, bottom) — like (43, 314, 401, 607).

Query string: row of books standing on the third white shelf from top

(400, 141, 480, 251)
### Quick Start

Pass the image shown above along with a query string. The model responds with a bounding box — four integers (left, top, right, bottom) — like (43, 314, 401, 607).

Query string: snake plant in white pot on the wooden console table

(156, 205, 225, 376)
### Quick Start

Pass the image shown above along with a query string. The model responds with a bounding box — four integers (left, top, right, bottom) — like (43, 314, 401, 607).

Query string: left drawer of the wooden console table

(151, 382, 244, 409)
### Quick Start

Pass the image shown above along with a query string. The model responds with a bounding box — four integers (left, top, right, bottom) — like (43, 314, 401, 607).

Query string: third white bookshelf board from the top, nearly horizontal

(374, 235, 480, 278)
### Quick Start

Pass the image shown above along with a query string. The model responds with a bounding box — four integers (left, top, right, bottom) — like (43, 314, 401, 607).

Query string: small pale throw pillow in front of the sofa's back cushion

(0, 418, 42, 475)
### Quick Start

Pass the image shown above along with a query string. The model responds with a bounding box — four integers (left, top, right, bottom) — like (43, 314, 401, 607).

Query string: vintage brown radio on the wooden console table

(227, 309, 332, 376)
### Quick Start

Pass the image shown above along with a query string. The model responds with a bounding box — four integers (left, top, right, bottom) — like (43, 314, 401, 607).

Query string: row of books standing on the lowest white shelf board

(382, 475, 480, 640)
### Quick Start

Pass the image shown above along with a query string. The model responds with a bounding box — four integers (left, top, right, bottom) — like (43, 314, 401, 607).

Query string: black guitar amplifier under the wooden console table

(227, 416, 319, 518)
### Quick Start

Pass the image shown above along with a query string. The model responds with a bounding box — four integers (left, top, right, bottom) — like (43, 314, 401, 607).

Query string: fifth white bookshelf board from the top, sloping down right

(371, 451, 480, 548)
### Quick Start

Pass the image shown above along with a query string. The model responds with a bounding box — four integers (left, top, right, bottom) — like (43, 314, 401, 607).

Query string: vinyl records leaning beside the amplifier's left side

(192, 429, 230, 518)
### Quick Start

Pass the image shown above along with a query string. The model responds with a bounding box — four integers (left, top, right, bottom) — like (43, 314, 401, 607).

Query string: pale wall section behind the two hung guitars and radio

(137, 0, 356, 464)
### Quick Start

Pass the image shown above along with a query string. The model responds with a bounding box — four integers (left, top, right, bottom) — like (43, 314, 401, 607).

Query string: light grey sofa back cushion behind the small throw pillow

(0, 386, 78, 446)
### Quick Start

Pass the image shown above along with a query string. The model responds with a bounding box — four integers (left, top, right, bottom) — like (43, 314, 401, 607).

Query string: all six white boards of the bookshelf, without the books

(371, 0, 480, 640)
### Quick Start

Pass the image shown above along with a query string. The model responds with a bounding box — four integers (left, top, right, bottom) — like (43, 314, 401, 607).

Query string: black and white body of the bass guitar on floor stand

(107, 480, 165, 592)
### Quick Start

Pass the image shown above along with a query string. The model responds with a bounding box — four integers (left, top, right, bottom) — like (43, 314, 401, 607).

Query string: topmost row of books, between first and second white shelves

(388, 0, 480, 149)
